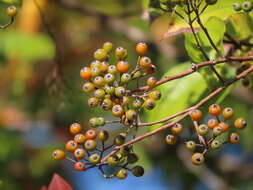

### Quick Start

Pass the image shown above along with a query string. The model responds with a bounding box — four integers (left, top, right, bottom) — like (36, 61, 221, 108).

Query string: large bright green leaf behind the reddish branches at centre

(146, 63, 207, 130)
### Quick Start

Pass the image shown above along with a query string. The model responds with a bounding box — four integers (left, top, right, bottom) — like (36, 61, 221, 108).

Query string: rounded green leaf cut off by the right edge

(226, 13, 253, 40)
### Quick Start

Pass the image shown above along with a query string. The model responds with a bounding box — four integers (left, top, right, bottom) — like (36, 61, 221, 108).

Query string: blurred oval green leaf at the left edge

(0, 31, 55, 61)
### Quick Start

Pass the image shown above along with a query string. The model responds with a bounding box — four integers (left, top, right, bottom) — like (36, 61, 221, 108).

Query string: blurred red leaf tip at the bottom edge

(48, 174, 73, 190)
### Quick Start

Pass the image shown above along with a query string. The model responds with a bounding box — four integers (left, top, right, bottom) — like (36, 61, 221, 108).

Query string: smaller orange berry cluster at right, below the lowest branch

(165, 104, 247, 165)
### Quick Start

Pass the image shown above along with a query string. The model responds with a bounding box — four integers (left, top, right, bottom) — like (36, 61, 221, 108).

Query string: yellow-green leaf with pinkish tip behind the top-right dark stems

(164, 0, 244, 38)
